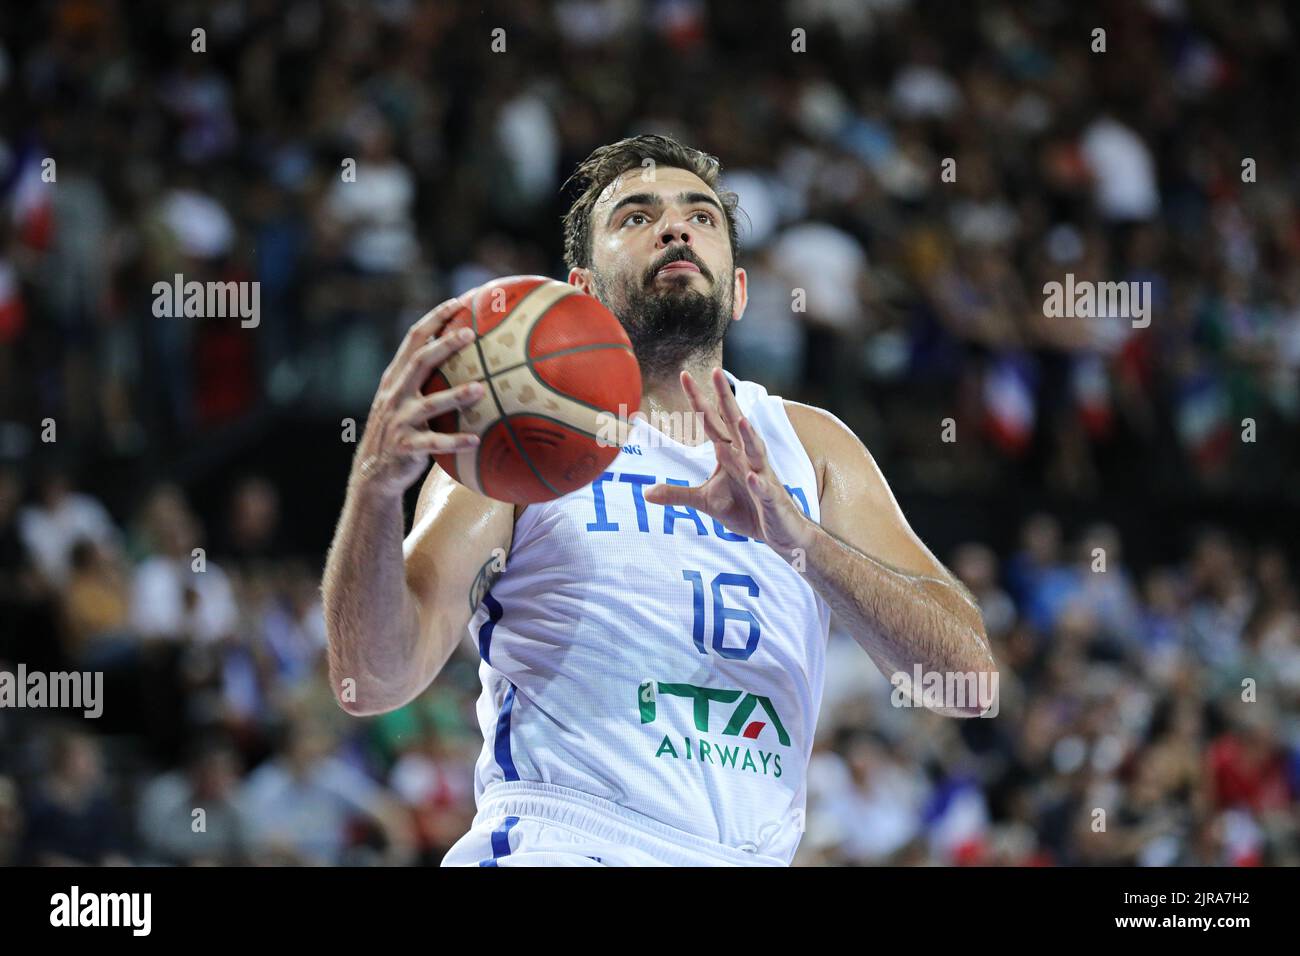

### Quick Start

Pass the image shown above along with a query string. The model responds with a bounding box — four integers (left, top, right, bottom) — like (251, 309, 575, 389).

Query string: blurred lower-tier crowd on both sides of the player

(0, 470, 1300, 865)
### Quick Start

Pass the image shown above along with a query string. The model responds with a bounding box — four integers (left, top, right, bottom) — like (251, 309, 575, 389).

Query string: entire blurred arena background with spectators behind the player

(0, 0, 1300, 865)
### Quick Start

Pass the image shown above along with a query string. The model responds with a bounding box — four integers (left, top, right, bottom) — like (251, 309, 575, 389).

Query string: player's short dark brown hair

(563, 134, 740, 269)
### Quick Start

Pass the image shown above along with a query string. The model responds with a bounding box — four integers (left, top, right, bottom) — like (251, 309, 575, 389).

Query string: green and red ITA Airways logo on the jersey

(637, 680, 790, 778)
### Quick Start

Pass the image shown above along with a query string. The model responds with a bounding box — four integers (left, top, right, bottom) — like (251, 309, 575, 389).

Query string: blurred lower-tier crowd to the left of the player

(0, 468, 481, 865)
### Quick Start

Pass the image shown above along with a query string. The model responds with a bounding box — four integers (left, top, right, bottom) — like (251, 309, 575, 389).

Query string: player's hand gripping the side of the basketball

(352, 299, 485, 496)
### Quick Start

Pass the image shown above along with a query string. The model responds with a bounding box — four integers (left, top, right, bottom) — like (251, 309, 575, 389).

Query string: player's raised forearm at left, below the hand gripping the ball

(321, 480, 428, 714)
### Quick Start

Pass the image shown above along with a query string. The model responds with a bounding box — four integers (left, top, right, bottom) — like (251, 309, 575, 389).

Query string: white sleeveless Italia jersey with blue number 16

(469, 373, 829, 862)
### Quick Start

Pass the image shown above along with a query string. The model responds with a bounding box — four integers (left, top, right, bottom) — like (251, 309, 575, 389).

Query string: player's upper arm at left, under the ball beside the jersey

(403, 464, 516, 685)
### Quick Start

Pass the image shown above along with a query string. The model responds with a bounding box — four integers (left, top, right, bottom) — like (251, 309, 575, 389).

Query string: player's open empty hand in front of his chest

(645, 367, 815, 561)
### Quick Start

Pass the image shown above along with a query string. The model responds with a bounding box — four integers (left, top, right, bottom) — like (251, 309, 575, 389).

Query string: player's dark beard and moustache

(593, 247, 732, 380)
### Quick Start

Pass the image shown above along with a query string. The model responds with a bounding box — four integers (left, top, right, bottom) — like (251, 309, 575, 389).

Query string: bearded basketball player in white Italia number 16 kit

(324, 135, 995, 866)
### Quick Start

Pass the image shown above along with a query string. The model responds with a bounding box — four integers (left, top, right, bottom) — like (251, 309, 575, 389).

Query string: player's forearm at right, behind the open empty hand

(803, 525, 997, 676)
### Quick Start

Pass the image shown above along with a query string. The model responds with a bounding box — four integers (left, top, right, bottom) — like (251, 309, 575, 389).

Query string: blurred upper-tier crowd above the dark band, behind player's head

(0, 0, 1300, 494)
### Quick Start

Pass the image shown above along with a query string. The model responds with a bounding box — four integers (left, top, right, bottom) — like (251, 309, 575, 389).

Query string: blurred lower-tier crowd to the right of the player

(801, 514, 1300, 866)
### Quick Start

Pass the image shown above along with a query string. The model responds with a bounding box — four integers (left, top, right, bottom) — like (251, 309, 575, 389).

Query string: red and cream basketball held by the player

(424, 276, 641, 505)
